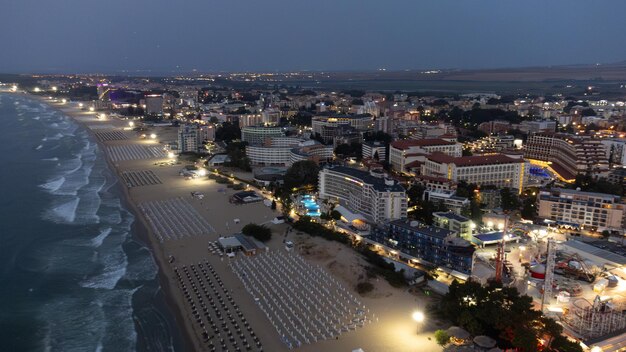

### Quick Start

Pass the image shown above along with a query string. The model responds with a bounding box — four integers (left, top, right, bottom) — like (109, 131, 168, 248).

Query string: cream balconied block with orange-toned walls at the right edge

(537, 188, 626, 231)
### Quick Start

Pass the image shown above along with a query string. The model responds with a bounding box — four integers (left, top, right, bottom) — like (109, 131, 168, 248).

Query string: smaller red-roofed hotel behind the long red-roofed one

(389, 138, 463, 173)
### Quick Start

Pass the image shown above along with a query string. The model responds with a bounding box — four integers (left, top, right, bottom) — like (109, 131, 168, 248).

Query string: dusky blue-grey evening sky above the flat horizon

(0, 0, 626, 72)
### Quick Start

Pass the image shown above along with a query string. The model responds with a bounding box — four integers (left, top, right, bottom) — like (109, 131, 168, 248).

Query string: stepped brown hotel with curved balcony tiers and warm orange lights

(524, 132, 608, 180)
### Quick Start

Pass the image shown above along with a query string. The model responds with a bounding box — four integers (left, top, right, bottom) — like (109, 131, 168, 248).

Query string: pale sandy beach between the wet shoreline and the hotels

(37, 97, 441, 352)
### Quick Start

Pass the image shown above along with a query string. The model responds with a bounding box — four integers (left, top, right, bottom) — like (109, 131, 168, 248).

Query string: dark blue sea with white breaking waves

(0, 93, 184, 352)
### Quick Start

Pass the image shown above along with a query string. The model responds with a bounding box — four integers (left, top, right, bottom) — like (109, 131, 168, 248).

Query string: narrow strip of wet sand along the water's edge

(23, 92, 199, 351)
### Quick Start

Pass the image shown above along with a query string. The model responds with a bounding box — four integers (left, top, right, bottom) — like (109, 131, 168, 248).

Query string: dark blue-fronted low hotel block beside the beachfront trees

(368, 219, 475, 275)
